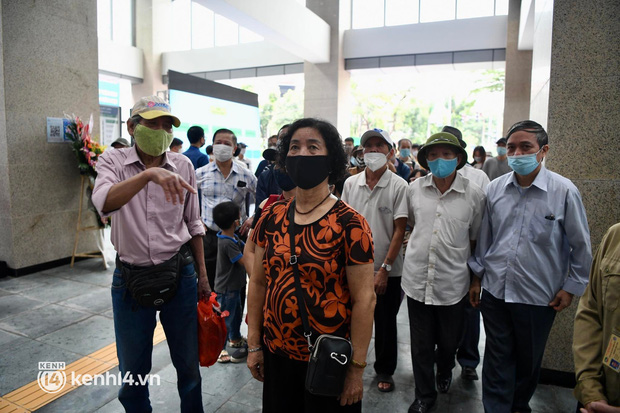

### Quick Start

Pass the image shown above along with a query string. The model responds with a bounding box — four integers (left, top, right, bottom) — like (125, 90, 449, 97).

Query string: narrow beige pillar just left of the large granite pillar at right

(502, 0, 532, 135)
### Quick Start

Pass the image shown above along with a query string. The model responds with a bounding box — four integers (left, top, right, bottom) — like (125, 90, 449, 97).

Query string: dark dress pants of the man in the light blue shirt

(480, 290, 555, 413)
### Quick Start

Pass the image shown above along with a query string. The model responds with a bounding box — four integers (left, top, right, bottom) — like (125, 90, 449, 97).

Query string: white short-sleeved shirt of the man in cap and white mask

(342, 169, 407, 277)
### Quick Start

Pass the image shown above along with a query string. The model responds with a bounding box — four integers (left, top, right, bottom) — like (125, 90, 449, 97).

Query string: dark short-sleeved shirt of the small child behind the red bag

(214, 231, 246, 293)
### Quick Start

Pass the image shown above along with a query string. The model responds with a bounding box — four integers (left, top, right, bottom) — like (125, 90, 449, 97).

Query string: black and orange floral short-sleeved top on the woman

(252, 200, 373, 361)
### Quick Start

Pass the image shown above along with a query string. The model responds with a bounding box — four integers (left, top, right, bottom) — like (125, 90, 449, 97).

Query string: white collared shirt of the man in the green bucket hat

(401, 173, 485, 305)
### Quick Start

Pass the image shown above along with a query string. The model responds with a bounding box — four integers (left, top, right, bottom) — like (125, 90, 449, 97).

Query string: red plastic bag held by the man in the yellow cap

(198, 293, 228, 367)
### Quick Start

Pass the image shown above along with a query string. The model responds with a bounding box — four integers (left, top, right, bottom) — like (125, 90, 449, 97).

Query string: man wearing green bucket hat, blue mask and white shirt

(402, 132, 485, 413)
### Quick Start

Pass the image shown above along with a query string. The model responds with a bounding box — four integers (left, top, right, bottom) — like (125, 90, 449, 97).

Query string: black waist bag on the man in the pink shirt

(121, 246, 193, 307)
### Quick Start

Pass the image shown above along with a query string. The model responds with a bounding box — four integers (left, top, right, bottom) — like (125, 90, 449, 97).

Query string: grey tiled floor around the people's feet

(0, 240, 575, 413)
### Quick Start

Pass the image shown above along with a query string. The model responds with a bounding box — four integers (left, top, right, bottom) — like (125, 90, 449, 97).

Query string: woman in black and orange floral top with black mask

(247, 118, 375, 413)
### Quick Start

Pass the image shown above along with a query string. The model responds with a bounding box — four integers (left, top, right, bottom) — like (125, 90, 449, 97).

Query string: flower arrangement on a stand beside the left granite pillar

(65, 114, 109, 269)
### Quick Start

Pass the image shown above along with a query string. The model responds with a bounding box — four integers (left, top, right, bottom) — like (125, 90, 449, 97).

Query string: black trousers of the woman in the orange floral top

(263, 346, 362, 413)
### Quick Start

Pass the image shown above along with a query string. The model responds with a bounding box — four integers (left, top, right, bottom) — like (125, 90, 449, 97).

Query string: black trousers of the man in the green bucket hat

(407, 296, 467, 403)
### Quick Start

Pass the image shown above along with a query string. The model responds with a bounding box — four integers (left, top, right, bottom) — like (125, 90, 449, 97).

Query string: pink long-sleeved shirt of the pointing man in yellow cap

(92, 147, 204, 266)
